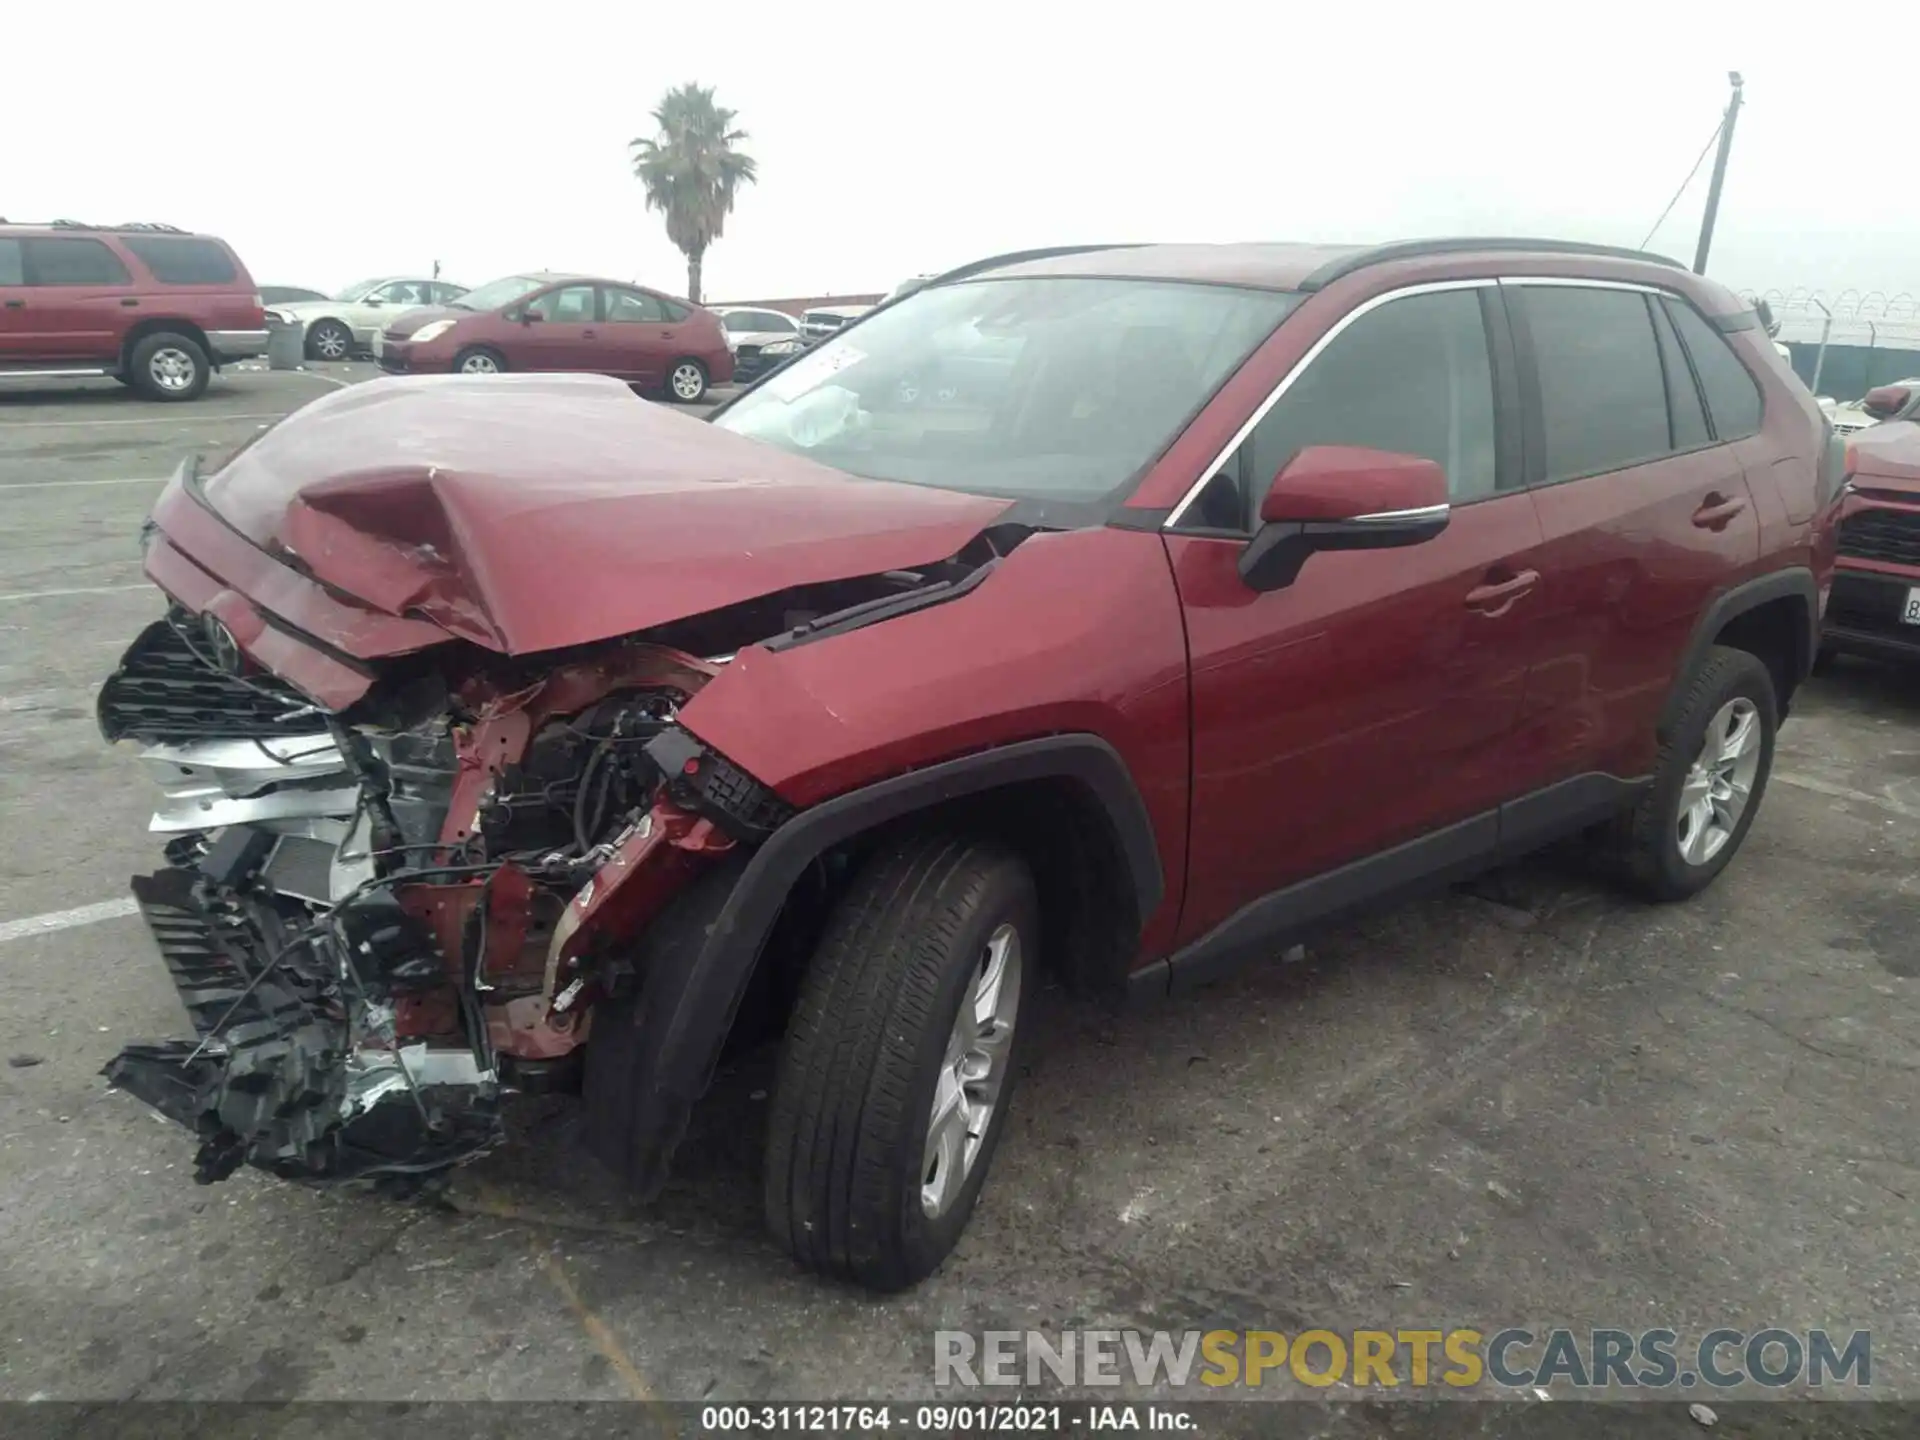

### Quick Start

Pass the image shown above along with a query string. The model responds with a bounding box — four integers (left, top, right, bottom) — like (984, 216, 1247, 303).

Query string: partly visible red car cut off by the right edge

(1820, 380, 1920, 662)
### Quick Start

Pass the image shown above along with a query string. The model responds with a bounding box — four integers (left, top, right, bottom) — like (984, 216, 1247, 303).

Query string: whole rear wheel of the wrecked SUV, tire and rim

(1615, 645, 1778, 900)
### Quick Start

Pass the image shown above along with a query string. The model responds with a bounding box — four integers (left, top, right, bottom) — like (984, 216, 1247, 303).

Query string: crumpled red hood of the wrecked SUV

(202, 374, 1008, 655)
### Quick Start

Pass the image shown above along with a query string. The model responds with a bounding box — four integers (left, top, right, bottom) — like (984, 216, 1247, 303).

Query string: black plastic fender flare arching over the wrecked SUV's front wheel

(588, 733, 1165, 1194)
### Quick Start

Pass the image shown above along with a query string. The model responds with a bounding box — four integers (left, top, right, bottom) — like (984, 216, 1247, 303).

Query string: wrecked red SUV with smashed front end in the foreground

(100, 240, 1839, 1288)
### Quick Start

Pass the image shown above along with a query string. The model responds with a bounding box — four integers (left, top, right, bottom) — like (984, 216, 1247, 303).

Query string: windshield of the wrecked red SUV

(714, 276, 1300, 501)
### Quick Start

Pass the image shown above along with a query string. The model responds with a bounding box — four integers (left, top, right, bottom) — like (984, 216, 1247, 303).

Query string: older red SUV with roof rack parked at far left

(0, 221, 267, 399)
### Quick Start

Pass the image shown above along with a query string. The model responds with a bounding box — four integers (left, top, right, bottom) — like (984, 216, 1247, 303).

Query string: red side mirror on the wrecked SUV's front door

(1240, 445, 1450, 589)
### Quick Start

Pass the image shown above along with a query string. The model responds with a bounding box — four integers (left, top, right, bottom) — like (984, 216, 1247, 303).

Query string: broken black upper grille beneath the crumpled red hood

(96, 620, 315, 745)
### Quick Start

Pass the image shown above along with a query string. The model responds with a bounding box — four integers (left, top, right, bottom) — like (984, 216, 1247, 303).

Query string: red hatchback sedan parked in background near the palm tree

(374, 271, 733, 403)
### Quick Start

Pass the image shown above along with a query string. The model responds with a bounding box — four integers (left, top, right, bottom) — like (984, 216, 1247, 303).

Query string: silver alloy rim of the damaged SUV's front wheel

(920, 924, 1021, 1219)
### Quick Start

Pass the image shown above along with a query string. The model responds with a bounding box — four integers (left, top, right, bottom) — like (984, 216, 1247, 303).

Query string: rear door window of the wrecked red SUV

(1513, 286, 1672, 484)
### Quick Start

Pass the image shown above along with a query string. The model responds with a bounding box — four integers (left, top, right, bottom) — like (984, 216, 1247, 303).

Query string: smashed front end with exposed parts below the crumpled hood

(98, 609, 764, 1183)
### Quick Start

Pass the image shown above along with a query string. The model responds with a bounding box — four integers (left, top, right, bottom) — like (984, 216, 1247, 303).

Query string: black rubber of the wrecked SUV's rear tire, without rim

(1611, 645, 1780, 900)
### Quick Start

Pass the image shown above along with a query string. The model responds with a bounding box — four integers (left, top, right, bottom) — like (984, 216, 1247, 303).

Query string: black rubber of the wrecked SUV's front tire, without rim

(766, 833, 1039, 1290)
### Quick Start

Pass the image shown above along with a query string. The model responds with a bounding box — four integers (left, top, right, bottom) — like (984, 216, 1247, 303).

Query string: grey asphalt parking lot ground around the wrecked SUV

(0, 363, 1920, 1436)
